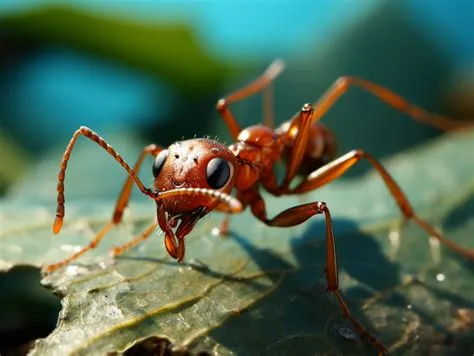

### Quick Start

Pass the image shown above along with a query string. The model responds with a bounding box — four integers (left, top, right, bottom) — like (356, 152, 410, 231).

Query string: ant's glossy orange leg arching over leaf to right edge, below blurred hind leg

(290, 150, 474, 259)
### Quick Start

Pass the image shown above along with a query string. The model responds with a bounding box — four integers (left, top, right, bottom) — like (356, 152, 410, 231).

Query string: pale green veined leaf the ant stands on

(0, 132, 474, 355)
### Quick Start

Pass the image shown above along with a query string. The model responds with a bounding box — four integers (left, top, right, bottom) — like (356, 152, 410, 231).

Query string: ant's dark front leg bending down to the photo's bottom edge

(246, 191, 388, 354)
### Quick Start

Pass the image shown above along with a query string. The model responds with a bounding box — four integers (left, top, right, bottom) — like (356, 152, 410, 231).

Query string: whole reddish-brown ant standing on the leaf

(44, 60, 474, 354)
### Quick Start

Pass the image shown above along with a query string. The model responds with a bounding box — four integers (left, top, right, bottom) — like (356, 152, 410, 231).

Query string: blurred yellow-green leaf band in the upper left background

(0, 5, 238, 96)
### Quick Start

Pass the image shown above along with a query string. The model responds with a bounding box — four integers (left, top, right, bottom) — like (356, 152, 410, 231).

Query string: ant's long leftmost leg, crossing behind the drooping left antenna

(43, 141, 162, 273)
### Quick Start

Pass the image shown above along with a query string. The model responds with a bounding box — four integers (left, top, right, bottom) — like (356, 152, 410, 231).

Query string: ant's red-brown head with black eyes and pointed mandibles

(152, 139, 238, 259)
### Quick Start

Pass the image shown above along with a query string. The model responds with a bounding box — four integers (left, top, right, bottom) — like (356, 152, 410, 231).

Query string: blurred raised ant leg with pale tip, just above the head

(216, 60, 284, 141)
